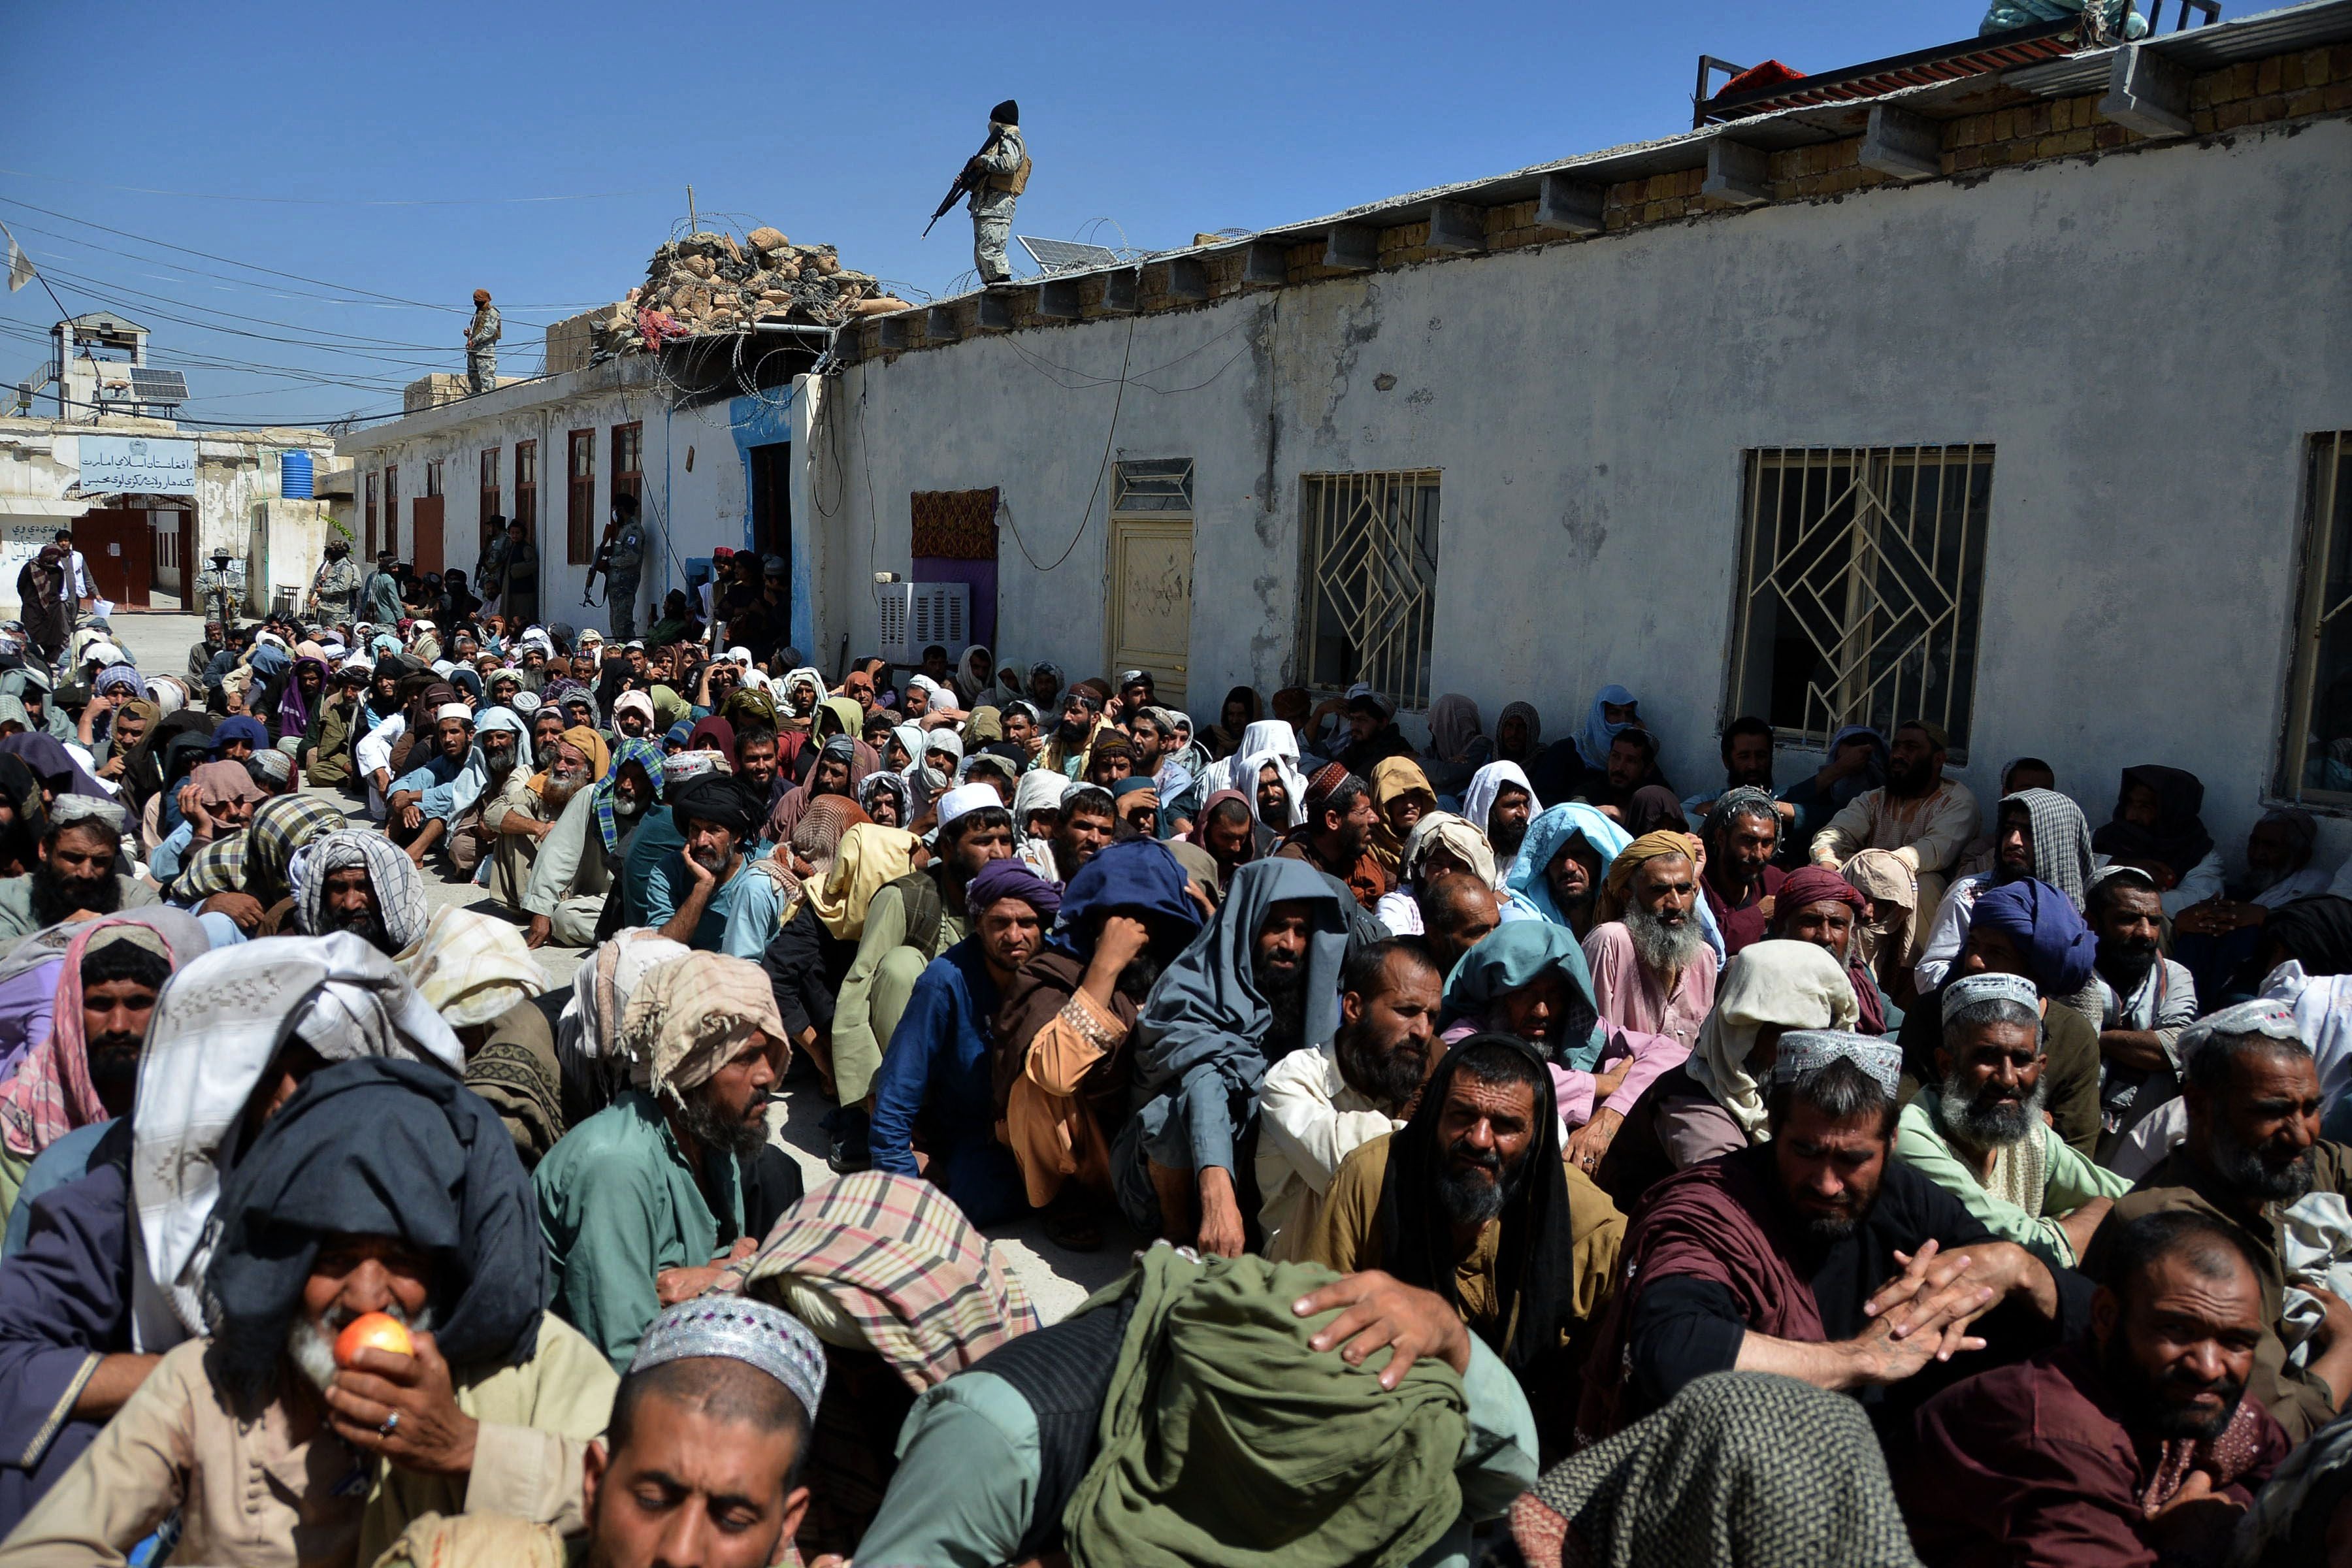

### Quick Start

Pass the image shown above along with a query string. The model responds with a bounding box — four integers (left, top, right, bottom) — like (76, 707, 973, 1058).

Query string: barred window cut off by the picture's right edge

(2277, 430, 2352, 806)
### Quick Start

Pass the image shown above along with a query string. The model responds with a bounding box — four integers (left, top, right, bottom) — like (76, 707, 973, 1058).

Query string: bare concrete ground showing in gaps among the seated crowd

(113, 613, 1138, 1321)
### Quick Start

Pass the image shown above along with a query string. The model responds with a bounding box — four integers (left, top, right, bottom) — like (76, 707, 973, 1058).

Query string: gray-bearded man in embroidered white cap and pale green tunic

(1896, 973, 2131, 1269)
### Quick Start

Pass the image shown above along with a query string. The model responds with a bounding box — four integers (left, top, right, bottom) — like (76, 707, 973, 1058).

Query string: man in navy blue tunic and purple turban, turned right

(870, 856, 1061, 1225)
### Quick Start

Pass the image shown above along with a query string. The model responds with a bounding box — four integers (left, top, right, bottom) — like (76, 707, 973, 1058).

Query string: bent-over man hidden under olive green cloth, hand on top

(858, 1246, 1536, 1568)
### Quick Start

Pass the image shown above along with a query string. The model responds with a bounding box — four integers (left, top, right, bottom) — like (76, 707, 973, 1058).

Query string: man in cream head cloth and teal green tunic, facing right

(532, 952, 791, 1366)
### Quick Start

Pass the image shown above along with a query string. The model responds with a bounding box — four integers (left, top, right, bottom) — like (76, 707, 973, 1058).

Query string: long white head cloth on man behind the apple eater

(132, 931, 466, 1354)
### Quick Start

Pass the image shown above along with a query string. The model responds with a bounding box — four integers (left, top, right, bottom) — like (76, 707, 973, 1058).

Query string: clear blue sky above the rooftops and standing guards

(0, 0, 1966, 423)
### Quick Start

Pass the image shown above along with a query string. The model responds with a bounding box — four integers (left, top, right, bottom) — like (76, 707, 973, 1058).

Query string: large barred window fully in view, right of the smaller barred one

(1724, 444, 1992, 759)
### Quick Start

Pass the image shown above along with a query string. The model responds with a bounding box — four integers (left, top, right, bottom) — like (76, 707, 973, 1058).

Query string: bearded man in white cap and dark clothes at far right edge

(2084, 999, 2352, 1443)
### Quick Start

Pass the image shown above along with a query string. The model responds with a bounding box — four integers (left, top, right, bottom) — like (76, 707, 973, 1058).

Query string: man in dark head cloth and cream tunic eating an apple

(9, 1060, 614, 1561)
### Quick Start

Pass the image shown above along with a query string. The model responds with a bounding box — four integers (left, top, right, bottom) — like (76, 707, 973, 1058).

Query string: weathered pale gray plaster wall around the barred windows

(811, 120, 2352, 858)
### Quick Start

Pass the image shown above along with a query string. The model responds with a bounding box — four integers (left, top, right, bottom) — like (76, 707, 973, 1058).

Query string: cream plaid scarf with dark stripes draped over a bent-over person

(720, 1171, 1037, 1392)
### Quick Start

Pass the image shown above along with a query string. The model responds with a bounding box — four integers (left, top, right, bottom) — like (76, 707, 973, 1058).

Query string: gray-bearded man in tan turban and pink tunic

(1585, 830, 1714, 1068)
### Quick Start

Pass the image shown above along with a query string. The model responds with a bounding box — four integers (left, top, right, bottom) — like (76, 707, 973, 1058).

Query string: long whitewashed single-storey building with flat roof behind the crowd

(344, 0, 2352, 858)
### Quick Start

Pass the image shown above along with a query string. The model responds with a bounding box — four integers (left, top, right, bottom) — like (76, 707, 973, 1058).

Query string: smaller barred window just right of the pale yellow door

(1301, 468, 1437, 708)
